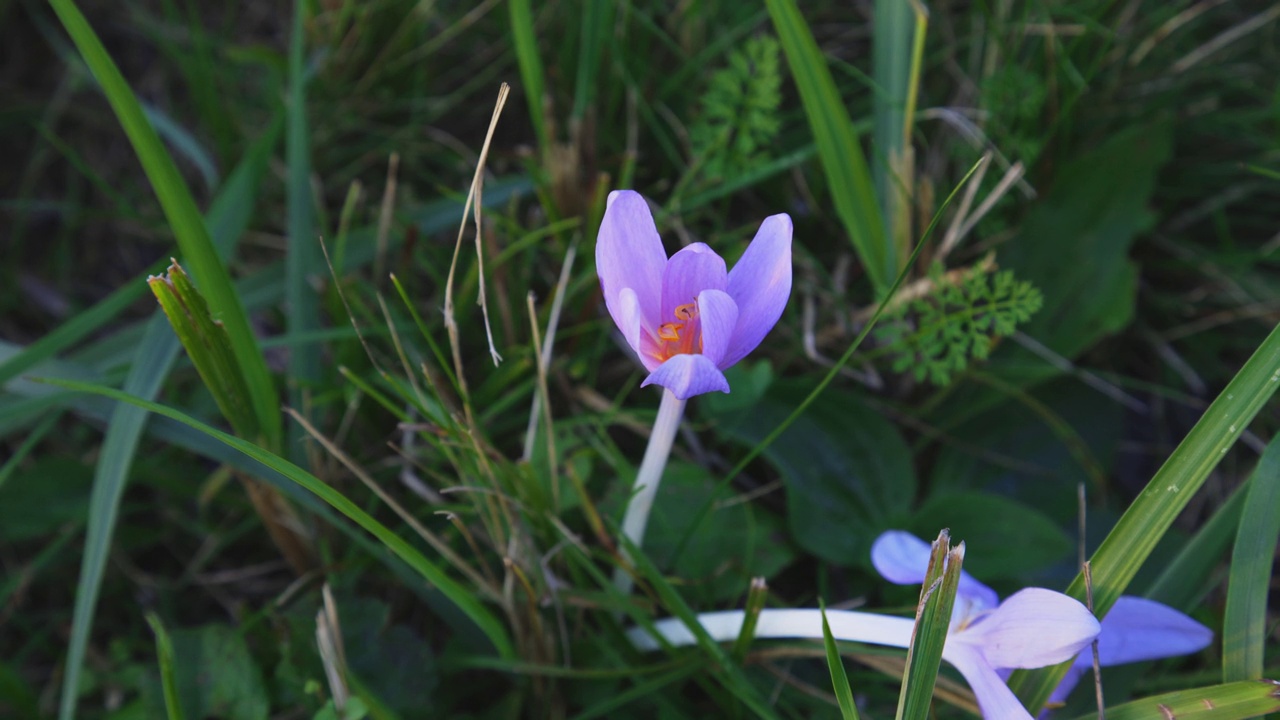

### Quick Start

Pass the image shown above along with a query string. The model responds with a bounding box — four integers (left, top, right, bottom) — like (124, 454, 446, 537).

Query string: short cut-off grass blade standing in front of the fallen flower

(896, 530, 964, 720)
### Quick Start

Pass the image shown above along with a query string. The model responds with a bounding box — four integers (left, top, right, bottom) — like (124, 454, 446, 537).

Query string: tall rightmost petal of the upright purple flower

(721, 213, 791, 368)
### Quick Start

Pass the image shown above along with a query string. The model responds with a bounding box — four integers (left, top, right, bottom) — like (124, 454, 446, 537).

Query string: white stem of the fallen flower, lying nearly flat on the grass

(627, 610, 915, 651)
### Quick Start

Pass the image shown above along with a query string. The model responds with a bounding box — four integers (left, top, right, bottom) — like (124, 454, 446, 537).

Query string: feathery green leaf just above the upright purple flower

(689, 35, 782, 179)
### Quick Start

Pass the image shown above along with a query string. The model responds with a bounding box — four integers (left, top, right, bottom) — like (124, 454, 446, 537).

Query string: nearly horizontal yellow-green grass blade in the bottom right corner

(1075, 680, 1280, 720)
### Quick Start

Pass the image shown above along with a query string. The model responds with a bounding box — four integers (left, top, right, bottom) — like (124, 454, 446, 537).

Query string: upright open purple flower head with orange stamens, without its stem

(595, 190, 791, 400)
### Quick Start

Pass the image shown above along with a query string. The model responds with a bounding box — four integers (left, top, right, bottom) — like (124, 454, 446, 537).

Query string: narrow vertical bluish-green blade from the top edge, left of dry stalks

(284, 0, 323, 443)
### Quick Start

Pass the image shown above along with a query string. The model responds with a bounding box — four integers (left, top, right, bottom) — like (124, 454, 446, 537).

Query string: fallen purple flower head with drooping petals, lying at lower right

(872, 530, 1213, 717)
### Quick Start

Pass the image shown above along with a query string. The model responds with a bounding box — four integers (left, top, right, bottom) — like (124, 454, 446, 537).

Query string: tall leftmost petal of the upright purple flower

(595, 190, 667, 335)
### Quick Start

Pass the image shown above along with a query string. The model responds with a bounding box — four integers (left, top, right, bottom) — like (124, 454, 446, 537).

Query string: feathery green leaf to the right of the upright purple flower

(876, 269, 1043, 386)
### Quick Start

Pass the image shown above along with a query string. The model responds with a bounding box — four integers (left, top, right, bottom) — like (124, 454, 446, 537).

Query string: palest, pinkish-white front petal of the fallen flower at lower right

(962, 588, 1101, 667)
